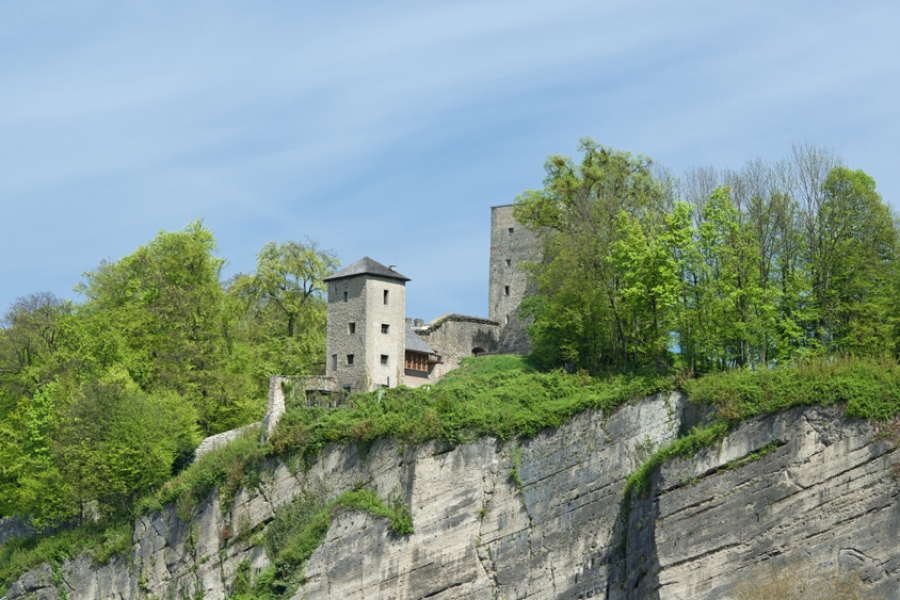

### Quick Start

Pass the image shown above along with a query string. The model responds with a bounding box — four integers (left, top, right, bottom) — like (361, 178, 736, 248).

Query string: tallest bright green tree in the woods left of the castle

(77, 221, 256, 433)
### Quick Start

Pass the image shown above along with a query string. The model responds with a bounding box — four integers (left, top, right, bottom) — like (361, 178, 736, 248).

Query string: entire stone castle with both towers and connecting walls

(307, 205, 538, 392)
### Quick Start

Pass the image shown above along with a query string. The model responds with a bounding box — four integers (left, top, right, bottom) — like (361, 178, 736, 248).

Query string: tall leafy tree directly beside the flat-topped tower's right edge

(514, 139, 670, 370)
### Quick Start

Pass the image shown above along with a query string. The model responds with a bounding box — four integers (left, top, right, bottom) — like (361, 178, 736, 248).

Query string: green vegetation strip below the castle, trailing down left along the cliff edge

(141, 355, 674, 518)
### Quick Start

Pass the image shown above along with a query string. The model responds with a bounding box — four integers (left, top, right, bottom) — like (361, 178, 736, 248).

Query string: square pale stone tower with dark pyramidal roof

(325, 257, 409, 392)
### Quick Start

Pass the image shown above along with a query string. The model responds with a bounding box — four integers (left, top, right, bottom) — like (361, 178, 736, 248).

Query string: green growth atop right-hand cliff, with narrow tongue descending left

(626, 357, 900, 493)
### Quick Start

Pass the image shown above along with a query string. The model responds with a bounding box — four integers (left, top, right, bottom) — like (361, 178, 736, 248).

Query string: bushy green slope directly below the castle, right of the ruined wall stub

(270, 356, 674, 457)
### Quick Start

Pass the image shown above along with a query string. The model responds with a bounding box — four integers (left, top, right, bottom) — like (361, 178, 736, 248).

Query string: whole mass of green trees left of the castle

(0, 221, 338, 524)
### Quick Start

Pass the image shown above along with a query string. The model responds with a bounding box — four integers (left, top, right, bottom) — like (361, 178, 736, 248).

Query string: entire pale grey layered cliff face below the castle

(7, 394, 900, 600)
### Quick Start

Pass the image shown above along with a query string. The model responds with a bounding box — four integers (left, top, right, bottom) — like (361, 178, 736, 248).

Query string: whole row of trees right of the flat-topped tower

(515, 139, 900, 372)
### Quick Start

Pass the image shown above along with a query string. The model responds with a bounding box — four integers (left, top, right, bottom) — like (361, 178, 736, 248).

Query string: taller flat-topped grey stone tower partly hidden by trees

(488, 204, 540, 353)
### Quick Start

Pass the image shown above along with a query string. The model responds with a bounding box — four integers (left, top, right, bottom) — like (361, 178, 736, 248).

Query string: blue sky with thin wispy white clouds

(0, 0, 900, 319)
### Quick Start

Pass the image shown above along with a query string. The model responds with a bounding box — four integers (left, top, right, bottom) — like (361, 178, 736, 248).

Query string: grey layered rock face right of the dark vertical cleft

(634, 408, 900, 598)
